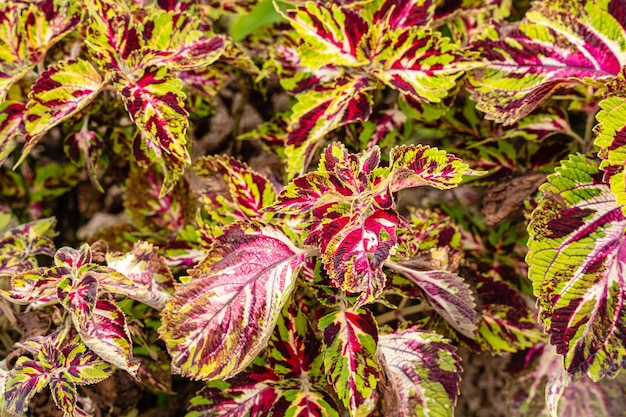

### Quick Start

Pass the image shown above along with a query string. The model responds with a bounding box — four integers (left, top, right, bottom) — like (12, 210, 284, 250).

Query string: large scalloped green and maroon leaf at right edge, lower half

(527, 155, 626, 380)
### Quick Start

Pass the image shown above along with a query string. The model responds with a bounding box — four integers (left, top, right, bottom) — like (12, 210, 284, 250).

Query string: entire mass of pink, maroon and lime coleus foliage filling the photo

(0, 0, 626, 416)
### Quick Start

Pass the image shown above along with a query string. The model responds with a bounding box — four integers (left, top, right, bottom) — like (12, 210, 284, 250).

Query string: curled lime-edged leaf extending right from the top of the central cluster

(389, 145, 470, 192)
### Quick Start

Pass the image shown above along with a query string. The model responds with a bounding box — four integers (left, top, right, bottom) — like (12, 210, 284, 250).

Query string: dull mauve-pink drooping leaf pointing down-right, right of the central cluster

(386, 261, 479, 339)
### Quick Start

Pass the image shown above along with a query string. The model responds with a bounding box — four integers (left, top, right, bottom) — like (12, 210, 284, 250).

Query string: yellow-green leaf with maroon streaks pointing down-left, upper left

(21, 59, 107, 160)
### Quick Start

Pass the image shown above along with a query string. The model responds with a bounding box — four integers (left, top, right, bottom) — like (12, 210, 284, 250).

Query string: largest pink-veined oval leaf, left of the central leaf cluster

(159, 225, 304, 379)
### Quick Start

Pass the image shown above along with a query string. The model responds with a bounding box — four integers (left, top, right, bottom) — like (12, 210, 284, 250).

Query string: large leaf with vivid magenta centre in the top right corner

(470, 0, 626, 124)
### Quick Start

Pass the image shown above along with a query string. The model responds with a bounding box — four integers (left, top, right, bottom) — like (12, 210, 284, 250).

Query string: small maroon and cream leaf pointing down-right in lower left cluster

(72, 300, 139, 376)
